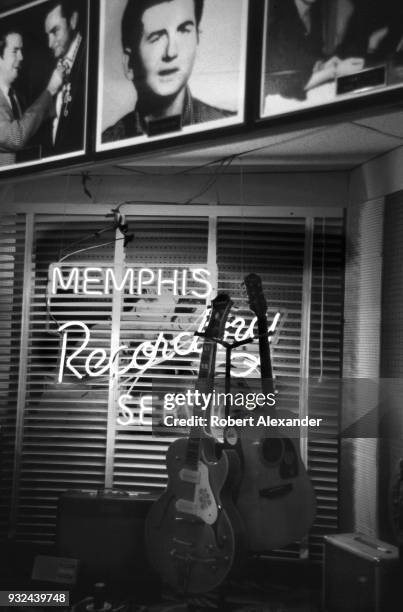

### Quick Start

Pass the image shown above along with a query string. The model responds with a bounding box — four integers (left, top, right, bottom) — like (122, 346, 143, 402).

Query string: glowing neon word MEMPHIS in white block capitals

(49, 264, 213, 299)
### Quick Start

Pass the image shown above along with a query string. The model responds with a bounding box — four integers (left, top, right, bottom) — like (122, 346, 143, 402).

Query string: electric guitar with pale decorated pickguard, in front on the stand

(146, 294, 242, 593)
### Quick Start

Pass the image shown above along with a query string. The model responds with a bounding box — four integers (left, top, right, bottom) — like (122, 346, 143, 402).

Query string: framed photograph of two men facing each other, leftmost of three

(0, 0, 89, 171)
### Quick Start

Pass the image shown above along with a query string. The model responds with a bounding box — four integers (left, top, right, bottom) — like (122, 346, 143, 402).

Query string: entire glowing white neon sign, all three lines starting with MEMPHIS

(48, 264, 281, 425)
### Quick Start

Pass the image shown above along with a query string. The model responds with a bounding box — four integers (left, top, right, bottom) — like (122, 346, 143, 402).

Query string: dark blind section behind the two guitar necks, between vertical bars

(217, 219, 305, 558)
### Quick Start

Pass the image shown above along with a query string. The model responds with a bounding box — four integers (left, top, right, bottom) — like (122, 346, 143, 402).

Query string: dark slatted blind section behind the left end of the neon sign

(17, 216, 115, 542)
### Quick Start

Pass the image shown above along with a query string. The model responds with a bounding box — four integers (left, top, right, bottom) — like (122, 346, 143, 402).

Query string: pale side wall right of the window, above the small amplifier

(342, 143, 403, 541)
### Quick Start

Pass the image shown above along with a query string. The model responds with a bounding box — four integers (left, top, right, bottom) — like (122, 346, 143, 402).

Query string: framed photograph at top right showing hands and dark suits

(260, 0, 403, 118)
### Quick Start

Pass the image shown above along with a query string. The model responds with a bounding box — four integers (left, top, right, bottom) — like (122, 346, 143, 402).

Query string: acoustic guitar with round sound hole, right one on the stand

(236, 274, 316, 552)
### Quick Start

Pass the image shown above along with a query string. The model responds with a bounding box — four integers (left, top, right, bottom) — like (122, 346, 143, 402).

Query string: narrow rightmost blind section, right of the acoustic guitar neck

(308, 219, 344, 558)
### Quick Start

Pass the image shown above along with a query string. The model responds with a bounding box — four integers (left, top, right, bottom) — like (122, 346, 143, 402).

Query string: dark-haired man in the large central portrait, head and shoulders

(102, 0, 233, 142)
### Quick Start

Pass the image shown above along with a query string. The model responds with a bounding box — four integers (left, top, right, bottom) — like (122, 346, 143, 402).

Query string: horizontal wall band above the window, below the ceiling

(0, 168, 348, 210)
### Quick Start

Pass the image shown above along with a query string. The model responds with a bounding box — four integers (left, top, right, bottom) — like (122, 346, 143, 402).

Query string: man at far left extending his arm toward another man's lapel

(0, 29, 64, 166)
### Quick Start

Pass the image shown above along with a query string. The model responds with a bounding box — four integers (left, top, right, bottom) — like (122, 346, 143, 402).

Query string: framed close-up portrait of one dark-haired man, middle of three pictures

(96, 0, 248, 151)
